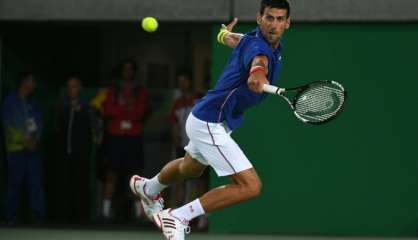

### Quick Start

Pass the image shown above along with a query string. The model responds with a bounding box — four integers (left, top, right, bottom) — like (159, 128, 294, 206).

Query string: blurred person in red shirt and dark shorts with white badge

(102, 59, 149, 218)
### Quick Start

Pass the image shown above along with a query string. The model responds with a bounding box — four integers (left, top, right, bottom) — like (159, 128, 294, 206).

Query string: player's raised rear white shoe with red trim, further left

(129, 175, 164, 221)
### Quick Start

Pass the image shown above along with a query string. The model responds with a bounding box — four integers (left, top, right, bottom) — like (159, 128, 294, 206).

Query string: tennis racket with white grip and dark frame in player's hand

(263, 80, 347, 125)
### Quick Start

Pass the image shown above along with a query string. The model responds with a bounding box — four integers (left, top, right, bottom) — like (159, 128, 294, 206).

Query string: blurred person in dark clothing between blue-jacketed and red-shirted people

(57, 77, 92, 223)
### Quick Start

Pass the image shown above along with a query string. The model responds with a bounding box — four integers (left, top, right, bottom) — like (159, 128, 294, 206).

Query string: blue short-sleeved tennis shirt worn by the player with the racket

(192, 27, 283, 130)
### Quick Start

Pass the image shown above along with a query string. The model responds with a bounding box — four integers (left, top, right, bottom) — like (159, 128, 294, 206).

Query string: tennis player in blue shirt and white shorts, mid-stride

(130, 0, 290, 240)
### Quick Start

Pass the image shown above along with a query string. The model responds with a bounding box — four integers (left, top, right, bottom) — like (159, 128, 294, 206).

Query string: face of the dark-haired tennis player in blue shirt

(257, 7, 290, 47)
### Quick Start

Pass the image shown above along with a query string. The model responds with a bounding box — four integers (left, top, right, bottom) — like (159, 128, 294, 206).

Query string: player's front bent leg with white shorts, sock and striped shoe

(154, 115, 261, 239)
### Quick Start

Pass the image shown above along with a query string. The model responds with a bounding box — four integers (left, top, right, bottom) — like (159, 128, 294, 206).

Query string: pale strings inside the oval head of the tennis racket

(295, 85, 345, 122)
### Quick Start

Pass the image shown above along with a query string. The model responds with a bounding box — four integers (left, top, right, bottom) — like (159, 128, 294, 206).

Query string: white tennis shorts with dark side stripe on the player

(184, 113, 253, 177)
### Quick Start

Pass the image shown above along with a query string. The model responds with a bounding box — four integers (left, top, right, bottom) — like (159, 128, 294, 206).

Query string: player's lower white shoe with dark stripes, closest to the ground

(154, 208, 190, 240)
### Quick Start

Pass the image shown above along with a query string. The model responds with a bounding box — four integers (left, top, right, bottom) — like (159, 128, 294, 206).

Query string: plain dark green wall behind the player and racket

(210, 23, 418, 236)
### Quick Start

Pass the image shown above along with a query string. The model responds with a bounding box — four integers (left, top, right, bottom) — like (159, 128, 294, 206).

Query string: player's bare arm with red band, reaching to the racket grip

(247, 55, 269, 93)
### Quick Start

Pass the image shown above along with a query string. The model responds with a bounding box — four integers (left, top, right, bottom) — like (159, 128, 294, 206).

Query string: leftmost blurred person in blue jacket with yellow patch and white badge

(2, 72, 45, 224)
